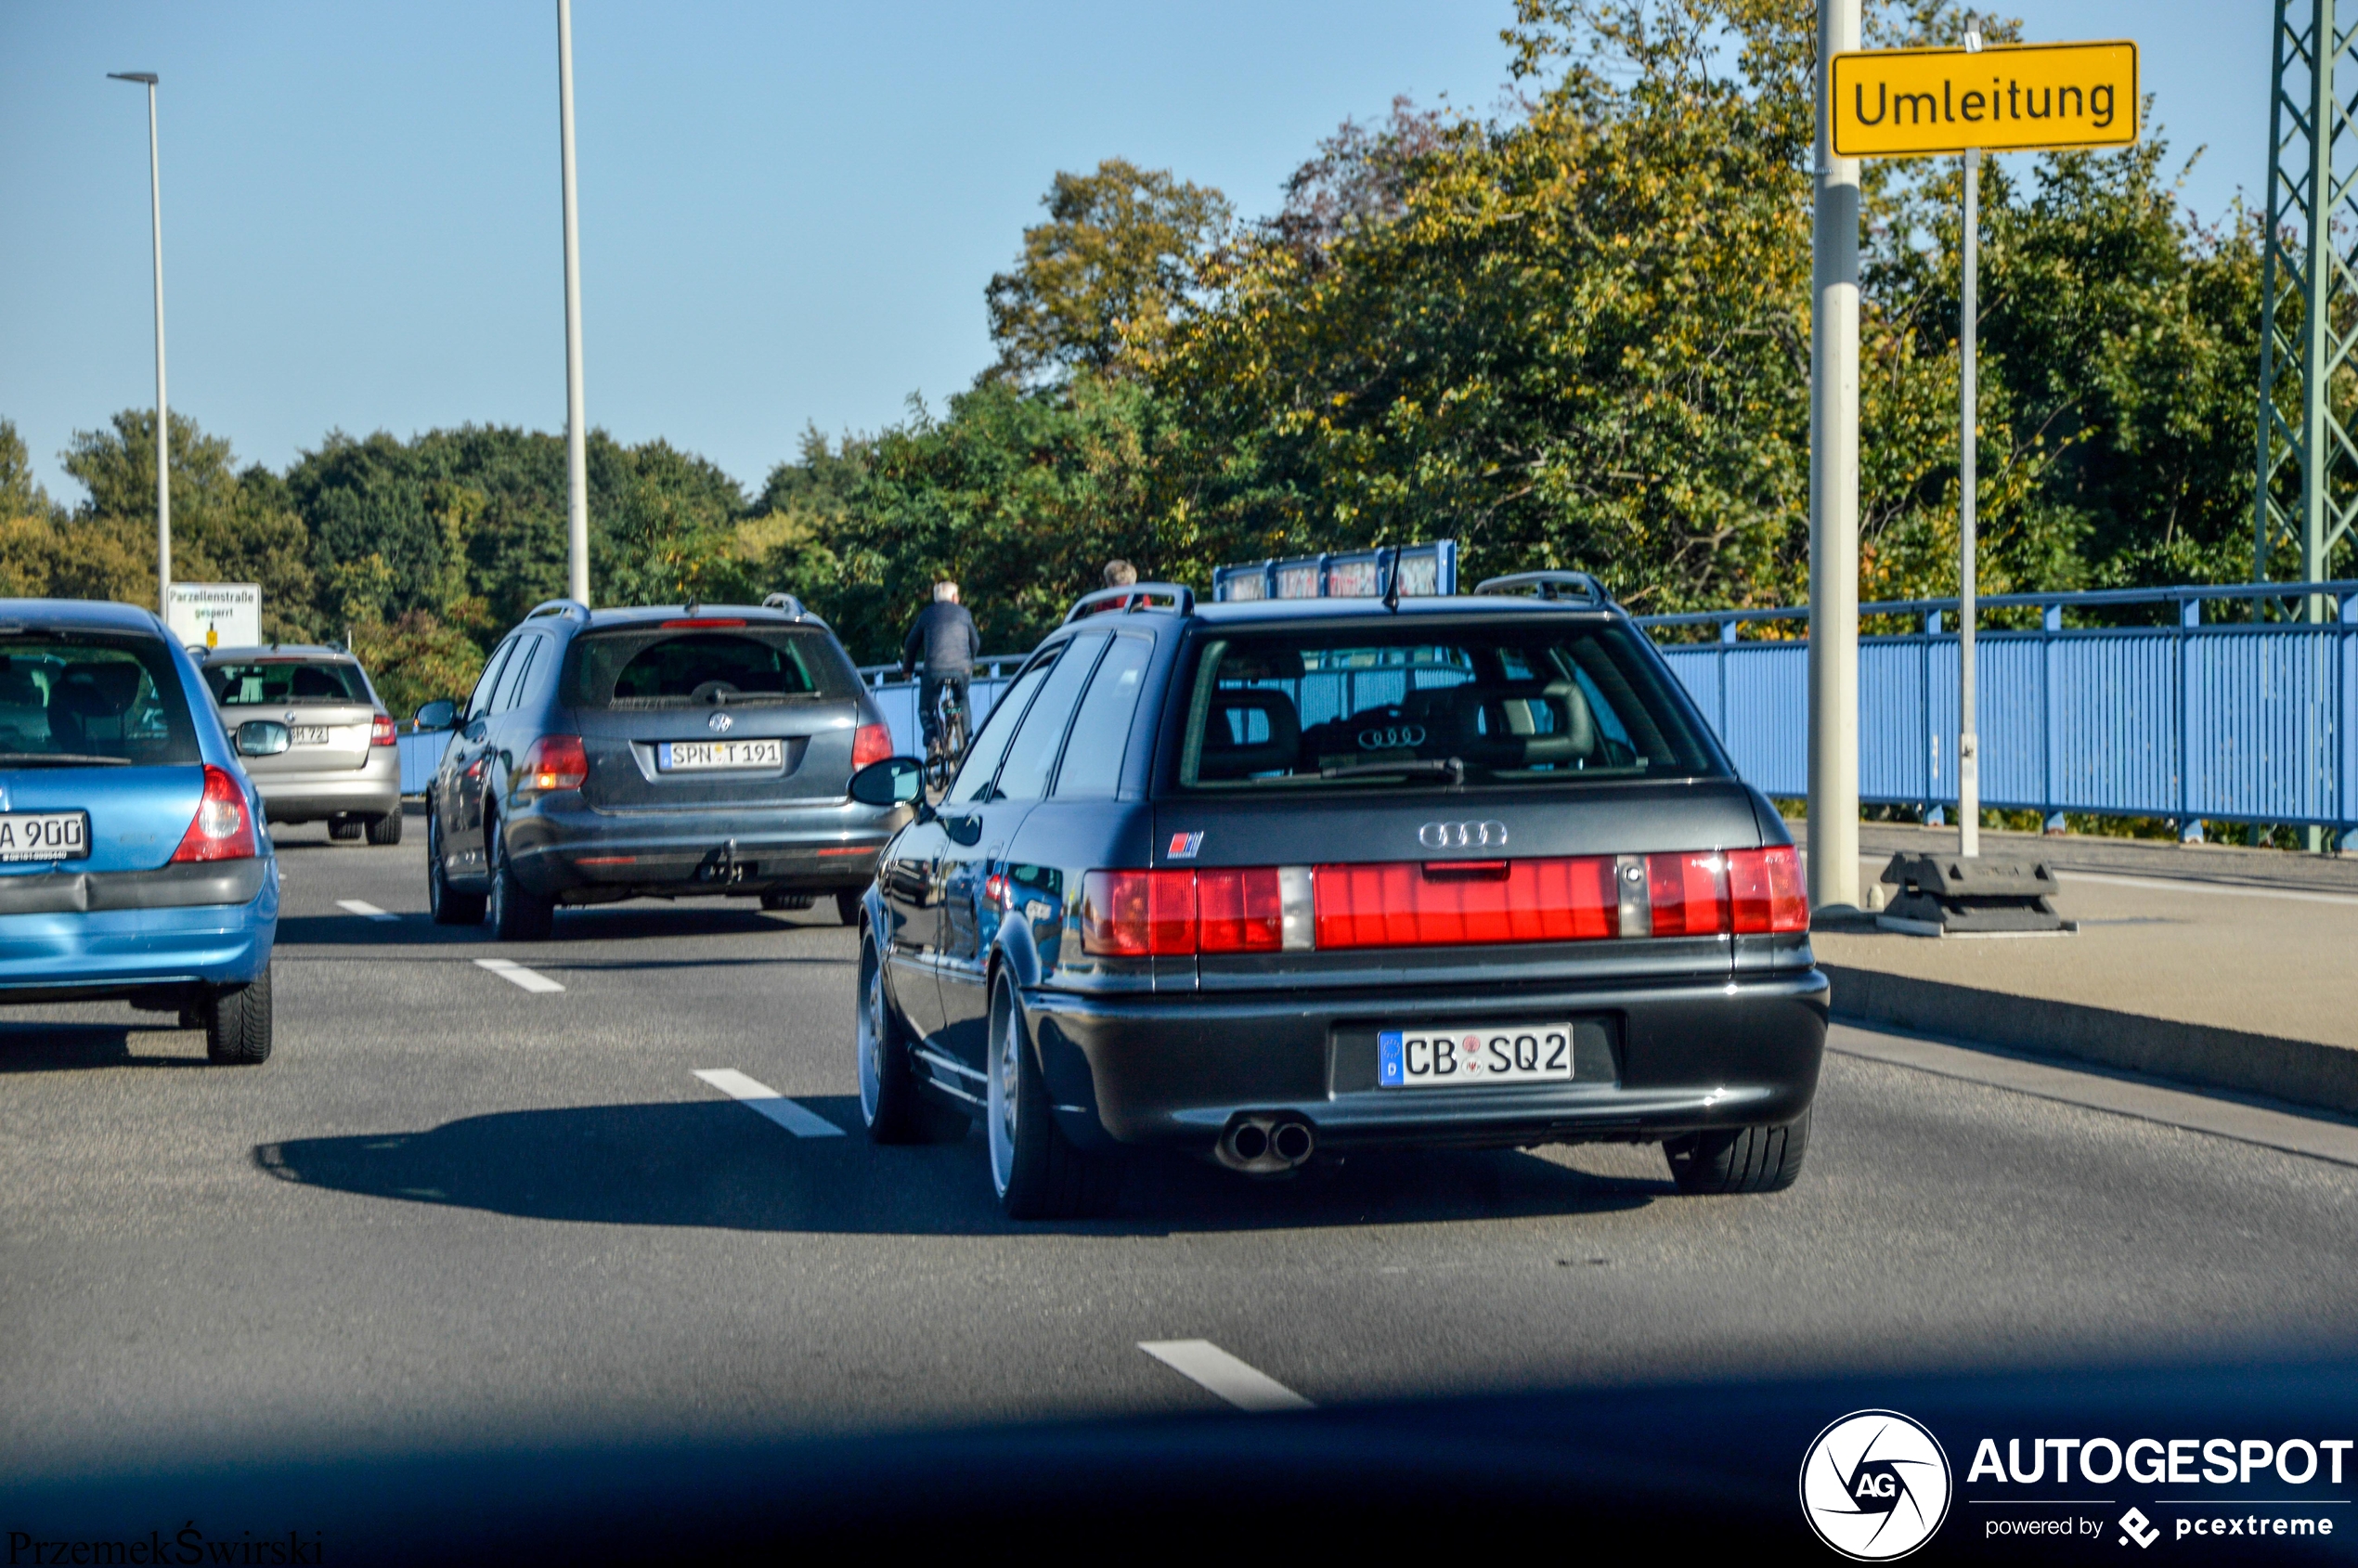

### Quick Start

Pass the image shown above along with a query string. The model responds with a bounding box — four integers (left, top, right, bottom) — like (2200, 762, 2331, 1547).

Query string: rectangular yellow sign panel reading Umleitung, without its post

(1828, 40, 2136, 158)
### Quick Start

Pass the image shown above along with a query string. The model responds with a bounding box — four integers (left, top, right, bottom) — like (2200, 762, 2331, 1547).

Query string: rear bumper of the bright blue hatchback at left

(0, 859, 279, 1002)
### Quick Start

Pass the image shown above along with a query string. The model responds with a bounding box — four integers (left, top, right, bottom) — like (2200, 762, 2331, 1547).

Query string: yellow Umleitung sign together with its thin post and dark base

(1825, 14, 2139, 934)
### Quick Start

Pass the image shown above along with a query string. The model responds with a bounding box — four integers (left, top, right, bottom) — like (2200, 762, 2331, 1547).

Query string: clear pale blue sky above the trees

(0, 0, 2271, 499)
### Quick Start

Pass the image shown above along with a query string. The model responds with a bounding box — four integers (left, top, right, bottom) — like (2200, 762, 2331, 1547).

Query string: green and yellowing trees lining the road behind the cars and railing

(0, 0, 2291, 709)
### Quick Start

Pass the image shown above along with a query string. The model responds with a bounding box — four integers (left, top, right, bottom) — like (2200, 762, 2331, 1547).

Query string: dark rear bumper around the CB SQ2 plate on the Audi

(1023, 969, 1828, 1150)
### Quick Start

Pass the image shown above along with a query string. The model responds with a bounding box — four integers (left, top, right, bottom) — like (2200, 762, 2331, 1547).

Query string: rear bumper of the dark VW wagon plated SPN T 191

(505, 795, 905, 903)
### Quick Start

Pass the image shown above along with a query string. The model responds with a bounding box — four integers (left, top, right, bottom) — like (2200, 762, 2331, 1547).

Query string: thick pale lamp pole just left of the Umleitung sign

(1808, 0, 1860, 910)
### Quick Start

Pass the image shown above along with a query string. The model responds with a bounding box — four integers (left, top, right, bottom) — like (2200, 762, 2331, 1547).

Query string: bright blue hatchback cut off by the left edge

(0, 599, 290, 1063)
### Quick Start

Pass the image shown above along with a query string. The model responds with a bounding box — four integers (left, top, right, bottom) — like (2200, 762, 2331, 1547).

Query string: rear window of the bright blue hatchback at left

(0, 632, 202, 769)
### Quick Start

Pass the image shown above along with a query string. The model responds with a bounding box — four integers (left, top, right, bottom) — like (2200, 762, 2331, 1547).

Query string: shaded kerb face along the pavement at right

(1820, 965, 2358, 1113)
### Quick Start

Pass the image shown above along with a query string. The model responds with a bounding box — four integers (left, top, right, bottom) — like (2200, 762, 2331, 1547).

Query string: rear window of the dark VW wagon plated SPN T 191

(562, 628, 859, 709)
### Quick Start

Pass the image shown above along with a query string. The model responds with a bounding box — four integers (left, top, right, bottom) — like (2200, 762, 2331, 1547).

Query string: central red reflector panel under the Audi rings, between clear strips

(1315, 856, 1620, 948)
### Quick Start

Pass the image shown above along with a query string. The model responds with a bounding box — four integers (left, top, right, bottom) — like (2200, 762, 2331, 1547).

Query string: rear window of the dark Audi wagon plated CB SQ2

(1179, 616, 1724, 795)
